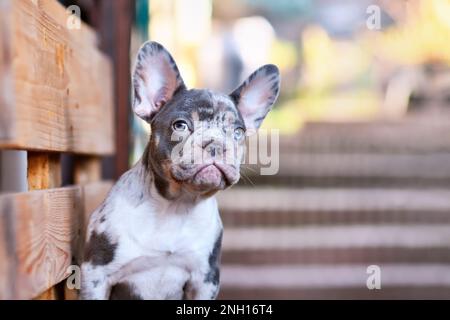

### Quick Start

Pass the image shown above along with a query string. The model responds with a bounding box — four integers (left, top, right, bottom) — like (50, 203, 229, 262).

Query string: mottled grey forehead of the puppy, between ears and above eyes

(153, 89, 245, 128)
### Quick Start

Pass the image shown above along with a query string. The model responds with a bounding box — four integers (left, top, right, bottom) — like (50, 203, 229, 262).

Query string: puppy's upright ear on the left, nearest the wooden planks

(133, 41, 186, 122)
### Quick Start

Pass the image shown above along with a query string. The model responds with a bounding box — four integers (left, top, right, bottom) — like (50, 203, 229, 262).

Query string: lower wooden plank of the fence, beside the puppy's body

(0, 182, 111, 299)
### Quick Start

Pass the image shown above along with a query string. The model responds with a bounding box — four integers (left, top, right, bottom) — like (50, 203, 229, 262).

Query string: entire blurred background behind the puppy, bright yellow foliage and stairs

(124, 0, 450, 299)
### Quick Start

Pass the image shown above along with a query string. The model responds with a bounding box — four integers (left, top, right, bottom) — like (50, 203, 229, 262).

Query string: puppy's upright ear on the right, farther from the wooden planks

(230, 64, 280, 132)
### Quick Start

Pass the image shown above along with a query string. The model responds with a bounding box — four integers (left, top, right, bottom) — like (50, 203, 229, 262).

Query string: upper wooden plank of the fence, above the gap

(0, 0, 114, 154)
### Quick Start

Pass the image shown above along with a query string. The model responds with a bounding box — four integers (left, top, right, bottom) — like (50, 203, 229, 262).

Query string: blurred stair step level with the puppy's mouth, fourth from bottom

(240, 152, 450, 187)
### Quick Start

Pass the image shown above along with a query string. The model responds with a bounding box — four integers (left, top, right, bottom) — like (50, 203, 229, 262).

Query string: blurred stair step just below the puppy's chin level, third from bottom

(218, 187, 450, 227)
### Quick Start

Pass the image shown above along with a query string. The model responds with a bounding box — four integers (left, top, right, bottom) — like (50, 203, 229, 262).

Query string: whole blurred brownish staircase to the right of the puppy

(218, 119, 450, 299)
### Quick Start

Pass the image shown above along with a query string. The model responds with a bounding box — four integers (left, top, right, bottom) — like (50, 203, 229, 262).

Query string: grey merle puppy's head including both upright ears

(133, 42, 280, 198)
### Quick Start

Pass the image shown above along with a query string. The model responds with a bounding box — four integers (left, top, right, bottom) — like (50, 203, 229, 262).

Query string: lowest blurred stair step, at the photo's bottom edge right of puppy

(219, 264, 450, 299)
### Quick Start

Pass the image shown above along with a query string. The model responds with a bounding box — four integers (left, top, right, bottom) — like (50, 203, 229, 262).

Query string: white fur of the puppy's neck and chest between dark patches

(84, 166, 222, 298)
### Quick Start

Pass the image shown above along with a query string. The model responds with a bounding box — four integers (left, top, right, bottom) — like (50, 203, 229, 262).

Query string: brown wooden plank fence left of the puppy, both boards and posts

(0, 0, 115, 299)
